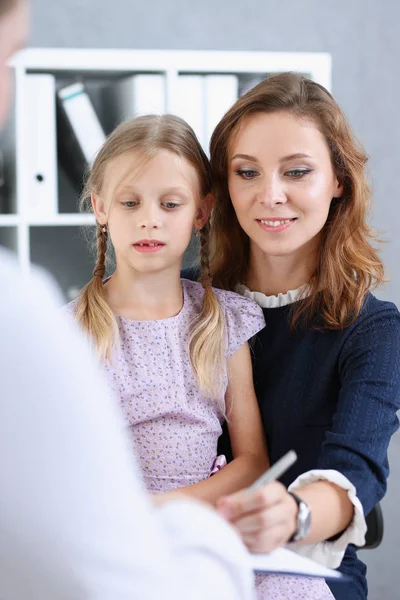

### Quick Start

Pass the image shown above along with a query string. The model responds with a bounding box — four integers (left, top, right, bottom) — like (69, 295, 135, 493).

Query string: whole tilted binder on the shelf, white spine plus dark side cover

(57, 82, 106, 191)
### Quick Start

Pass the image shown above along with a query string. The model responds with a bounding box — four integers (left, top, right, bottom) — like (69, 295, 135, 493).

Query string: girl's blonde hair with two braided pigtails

(76, 115, 225, 394)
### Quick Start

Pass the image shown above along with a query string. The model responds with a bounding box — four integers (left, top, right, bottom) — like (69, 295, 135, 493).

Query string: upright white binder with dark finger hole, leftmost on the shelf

(25, 74, 58, 217)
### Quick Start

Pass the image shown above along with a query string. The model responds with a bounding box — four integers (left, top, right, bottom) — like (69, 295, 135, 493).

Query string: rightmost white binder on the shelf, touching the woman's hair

(204, 75, 239, 148)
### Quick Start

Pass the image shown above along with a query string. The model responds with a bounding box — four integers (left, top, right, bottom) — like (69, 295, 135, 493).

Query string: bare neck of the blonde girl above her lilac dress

(104, 265, 183, 321)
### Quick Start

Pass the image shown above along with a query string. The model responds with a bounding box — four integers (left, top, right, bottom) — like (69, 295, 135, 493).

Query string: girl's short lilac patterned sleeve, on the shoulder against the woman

(214, 290, 265, 358)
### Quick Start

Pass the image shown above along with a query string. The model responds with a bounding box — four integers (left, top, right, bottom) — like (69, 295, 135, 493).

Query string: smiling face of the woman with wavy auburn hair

(228, 112, 343, 256)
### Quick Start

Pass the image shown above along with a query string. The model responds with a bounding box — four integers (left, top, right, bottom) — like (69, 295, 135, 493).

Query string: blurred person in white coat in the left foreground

(0, 0, 253, 600)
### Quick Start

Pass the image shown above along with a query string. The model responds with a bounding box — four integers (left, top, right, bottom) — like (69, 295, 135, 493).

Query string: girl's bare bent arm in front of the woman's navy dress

(157, 342, 268, 505)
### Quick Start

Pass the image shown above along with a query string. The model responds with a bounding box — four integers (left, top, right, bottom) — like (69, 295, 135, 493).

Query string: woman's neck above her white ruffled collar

(245, 247, 316, 296)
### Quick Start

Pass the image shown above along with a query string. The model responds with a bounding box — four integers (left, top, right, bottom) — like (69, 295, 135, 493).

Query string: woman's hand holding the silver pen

(217, 482, 298, 553)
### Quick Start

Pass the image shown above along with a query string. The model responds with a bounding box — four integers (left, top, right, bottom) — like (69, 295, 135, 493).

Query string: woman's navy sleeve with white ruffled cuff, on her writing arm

(291, 303, 400, 566)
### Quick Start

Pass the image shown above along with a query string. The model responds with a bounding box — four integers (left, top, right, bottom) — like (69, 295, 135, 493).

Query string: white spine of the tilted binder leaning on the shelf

(58, 83, 106, 165)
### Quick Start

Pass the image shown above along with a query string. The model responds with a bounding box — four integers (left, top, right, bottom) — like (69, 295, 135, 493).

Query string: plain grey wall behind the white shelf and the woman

(30, 0, 400, 600)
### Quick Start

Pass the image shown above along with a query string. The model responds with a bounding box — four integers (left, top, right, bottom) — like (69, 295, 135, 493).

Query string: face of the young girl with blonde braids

(92, 150, 208, 273)
